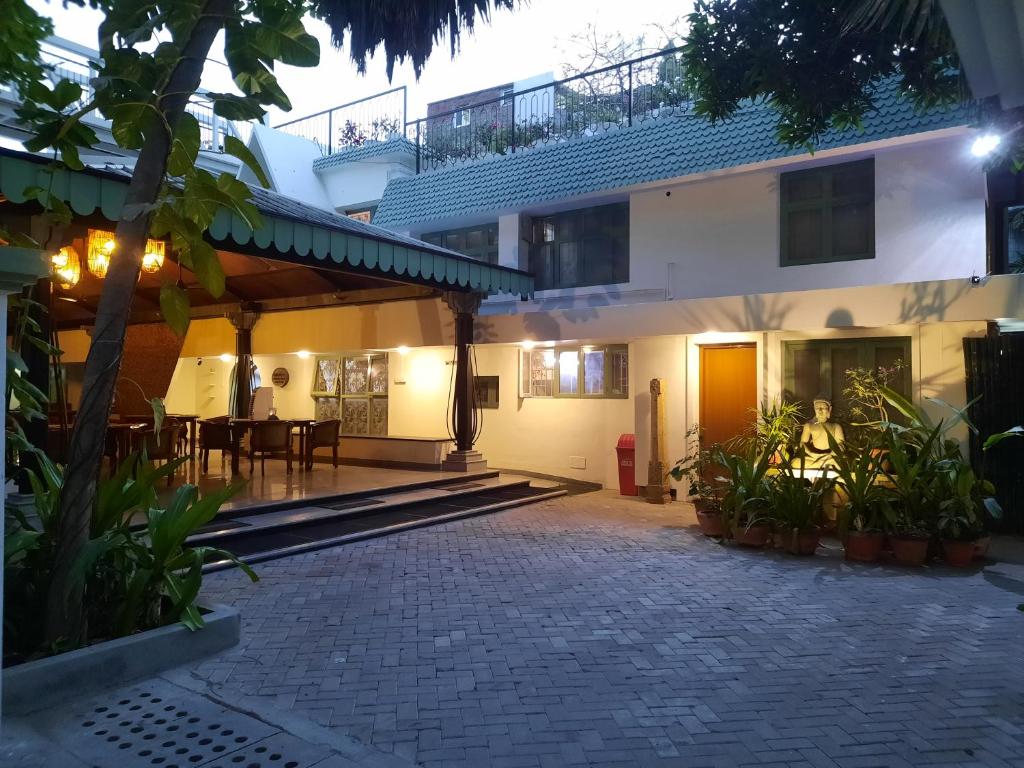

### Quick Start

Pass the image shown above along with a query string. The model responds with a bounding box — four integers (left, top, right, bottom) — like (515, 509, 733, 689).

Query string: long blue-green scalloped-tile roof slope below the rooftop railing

(374, 86, 970, 228)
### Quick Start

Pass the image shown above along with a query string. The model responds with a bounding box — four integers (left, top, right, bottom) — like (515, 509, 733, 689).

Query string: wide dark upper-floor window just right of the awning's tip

(529, 203, 630, 291)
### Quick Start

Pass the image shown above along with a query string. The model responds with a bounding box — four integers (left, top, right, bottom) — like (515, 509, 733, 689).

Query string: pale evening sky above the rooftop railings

(30, 0, 692, 125)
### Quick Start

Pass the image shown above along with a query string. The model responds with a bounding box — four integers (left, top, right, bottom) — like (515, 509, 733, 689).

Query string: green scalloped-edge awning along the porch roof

(0, 148, 534, 298)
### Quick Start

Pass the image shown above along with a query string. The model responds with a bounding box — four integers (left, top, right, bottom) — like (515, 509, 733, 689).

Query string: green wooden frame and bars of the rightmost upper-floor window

(779, 158, 876, 267)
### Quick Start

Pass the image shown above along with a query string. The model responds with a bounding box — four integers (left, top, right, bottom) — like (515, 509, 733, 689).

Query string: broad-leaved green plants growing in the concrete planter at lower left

(4, 453, 257, 659)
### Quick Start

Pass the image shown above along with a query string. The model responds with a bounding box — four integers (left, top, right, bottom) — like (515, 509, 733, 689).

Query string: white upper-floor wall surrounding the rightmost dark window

(622, 139, 985, 299)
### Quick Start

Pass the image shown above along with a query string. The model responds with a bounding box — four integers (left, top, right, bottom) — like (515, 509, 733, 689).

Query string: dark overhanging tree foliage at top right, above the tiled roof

(683, 0, 963, 148)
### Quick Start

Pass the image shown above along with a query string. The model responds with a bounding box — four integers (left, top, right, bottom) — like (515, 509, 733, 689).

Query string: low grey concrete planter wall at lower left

(3, 605, 241, 715)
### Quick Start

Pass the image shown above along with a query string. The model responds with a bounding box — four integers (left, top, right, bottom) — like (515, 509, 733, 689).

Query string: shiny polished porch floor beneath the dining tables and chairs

(158, 452, 479, 511)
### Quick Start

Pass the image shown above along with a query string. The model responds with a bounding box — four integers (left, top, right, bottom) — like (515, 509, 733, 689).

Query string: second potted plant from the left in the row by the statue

(715, 446, 775, 547)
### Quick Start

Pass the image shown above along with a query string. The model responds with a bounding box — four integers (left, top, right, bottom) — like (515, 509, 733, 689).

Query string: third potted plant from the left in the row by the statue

(768, 453, 834, 555)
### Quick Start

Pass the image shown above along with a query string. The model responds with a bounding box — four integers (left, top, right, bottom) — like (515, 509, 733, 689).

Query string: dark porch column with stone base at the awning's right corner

(441, 291, 487, 472)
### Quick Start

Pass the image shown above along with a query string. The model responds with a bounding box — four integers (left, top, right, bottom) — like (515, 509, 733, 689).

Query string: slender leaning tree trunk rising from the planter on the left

(46, 0, 230, 645)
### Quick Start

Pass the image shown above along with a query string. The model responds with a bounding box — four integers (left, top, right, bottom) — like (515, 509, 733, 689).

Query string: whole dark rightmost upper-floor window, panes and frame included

(779, 160, 874, 266)
